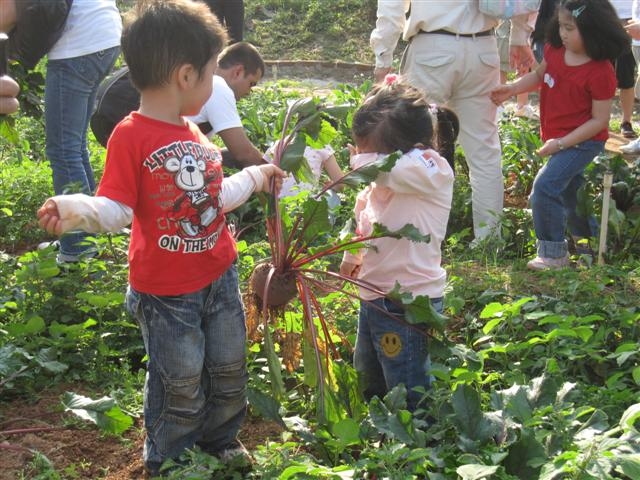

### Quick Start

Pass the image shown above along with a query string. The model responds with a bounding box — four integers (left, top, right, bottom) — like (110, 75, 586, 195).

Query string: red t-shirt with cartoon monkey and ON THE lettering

(97, 112, 237, 296)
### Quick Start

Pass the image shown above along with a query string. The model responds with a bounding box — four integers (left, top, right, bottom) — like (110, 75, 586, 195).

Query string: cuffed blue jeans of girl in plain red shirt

(529, 140, 604, 258)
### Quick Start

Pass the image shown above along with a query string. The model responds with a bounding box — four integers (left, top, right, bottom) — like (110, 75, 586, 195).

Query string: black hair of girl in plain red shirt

(546, 0, 631, 60)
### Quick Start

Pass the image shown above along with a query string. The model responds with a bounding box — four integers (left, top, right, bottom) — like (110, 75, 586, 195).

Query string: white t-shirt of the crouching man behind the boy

(187, 75, 242, 138)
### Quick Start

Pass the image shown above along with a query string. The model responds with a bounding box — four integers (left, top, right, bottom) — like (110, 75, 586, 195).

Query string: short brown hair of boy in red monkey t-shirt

(122, 0, 227, 90)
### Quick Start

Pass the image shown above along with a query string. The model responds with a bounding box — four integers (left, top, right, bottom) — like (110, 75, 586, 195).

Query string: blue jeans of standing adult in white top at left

(44, 47, 120, 260)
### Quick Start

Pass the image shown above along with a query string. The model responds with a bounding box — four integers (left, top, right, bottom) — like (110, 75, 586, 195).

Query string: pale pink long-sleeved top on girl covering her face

(344, 149, 453, 300)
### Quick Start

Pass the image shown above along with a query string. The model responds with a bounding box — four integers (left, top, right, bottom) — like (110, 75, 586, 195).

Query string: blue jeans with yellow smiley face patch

(353, 297, 443, 410)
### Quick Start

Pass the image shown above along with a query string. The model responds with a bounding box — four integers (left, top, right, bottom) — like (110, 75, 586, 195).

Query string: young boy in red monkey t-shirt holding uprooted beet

(38, 0, 284, 475)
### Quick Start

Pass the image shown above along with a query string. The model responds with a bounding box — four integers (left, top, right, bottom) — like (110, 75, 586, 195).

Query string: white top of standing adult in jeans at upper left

(48, 0, 122, 60)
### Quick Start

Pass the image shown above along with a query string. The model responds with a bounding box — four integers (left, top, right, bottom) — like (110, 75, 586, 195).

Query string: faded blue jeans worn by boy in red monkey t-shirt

(127, 266, 248, 473)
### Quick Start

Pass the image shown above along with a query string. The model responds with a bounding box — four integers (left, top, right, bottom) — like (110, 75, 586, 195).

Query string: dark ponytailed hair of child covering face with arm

(351, 81, 460, 165)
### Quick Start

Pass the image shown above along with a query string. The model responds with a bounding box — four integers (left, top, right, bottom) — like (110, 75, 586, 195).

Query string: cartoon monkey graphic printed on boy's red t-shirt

(164, 155, 220, 237)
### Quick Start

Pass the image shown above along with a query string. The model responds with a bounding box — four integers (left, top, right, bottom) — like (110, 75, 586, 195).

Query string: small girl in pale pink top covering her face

(340, 80, 458, 410)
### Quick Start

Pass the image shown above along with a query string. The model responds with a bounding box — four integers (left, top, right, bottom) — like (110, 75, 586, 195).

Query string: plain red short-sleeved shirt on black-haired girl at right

(540, 44, 616, 141)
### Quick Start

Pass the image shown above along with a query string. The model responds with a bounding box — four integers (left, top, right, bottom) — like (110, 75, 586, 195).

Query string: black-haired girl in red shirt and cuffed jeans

(491, 0, 630, 270)
